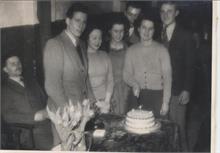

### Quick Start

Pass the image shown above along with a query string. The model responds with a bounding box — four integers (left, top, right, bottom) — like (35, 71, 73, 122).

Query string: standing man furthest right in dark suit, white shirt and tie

(160, 1, 195, 151)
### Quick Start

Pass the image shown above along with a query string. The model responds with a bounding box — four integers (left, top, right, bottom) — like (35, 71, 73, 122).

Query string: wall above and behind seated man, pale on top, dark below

(0, 1, 51, 84)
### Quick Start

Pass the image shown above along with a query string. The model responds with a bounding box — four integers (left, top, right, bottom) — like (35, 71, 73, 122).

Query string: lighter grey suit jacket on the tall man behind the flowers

(43, 31, 95, 111)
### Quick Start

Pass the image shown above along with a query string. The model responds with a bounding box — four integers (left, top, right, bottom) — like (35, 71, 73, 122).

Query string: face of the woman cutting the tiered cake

(138, 20, 154, 41)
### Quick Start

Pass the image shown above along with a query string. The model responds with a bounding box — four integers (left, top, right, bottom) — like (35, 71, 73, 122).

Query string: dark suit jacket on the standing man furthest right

(160, 24, 195, 95)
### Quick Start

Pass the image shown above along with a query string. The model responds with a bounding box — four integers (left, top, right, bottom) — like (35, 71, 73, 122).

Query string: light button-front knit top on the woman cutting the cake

(123, 41, 172, 101)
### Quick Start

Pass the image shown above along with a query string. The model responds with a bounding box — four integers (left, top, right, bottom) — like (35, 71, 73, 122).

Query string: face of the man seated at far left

(4, 56, 22, 77)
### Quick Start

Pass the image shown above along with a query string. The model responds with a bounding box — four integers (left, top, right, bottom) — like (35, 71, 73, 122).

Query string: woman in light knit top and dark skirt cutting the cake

(123, 16, 172, 118)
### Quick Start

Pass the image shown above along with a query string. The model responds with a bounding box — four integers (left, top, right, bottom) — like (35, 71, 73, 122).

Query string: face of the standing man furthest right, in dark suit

(160, 3, 179, 25)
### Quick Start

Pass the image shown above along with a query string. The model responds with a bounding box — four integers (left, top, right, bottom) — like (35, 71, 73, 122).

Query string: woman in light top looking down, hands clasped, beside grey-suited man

(84, 26, 113, 113)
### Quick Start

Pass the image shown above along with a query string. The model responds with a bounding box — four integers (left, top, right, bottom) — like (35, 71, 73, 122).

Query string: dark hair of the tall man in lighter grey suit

(66, 3, 88, 19)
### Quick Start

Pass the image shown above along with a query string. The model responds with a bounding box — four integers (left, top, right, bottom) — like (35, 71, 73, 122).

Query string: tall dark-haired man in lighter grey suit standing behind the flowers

(43, 3, 95, 145)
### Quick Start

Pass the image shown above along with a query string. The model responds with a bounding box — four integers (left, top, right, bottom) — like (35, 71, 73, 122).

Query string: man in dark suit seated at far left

(1, 54, 52, 150)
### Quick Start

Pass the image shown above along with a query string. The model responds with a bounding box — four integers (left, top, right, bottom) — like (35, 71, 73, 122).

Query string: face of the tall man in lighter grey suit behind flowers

(66, 12, 87, 38)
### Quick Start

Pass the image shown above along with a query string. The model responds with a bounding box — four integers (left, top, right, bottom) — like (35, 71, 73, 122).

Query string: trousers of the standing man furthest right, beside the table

(169, 96, 188, 151)
